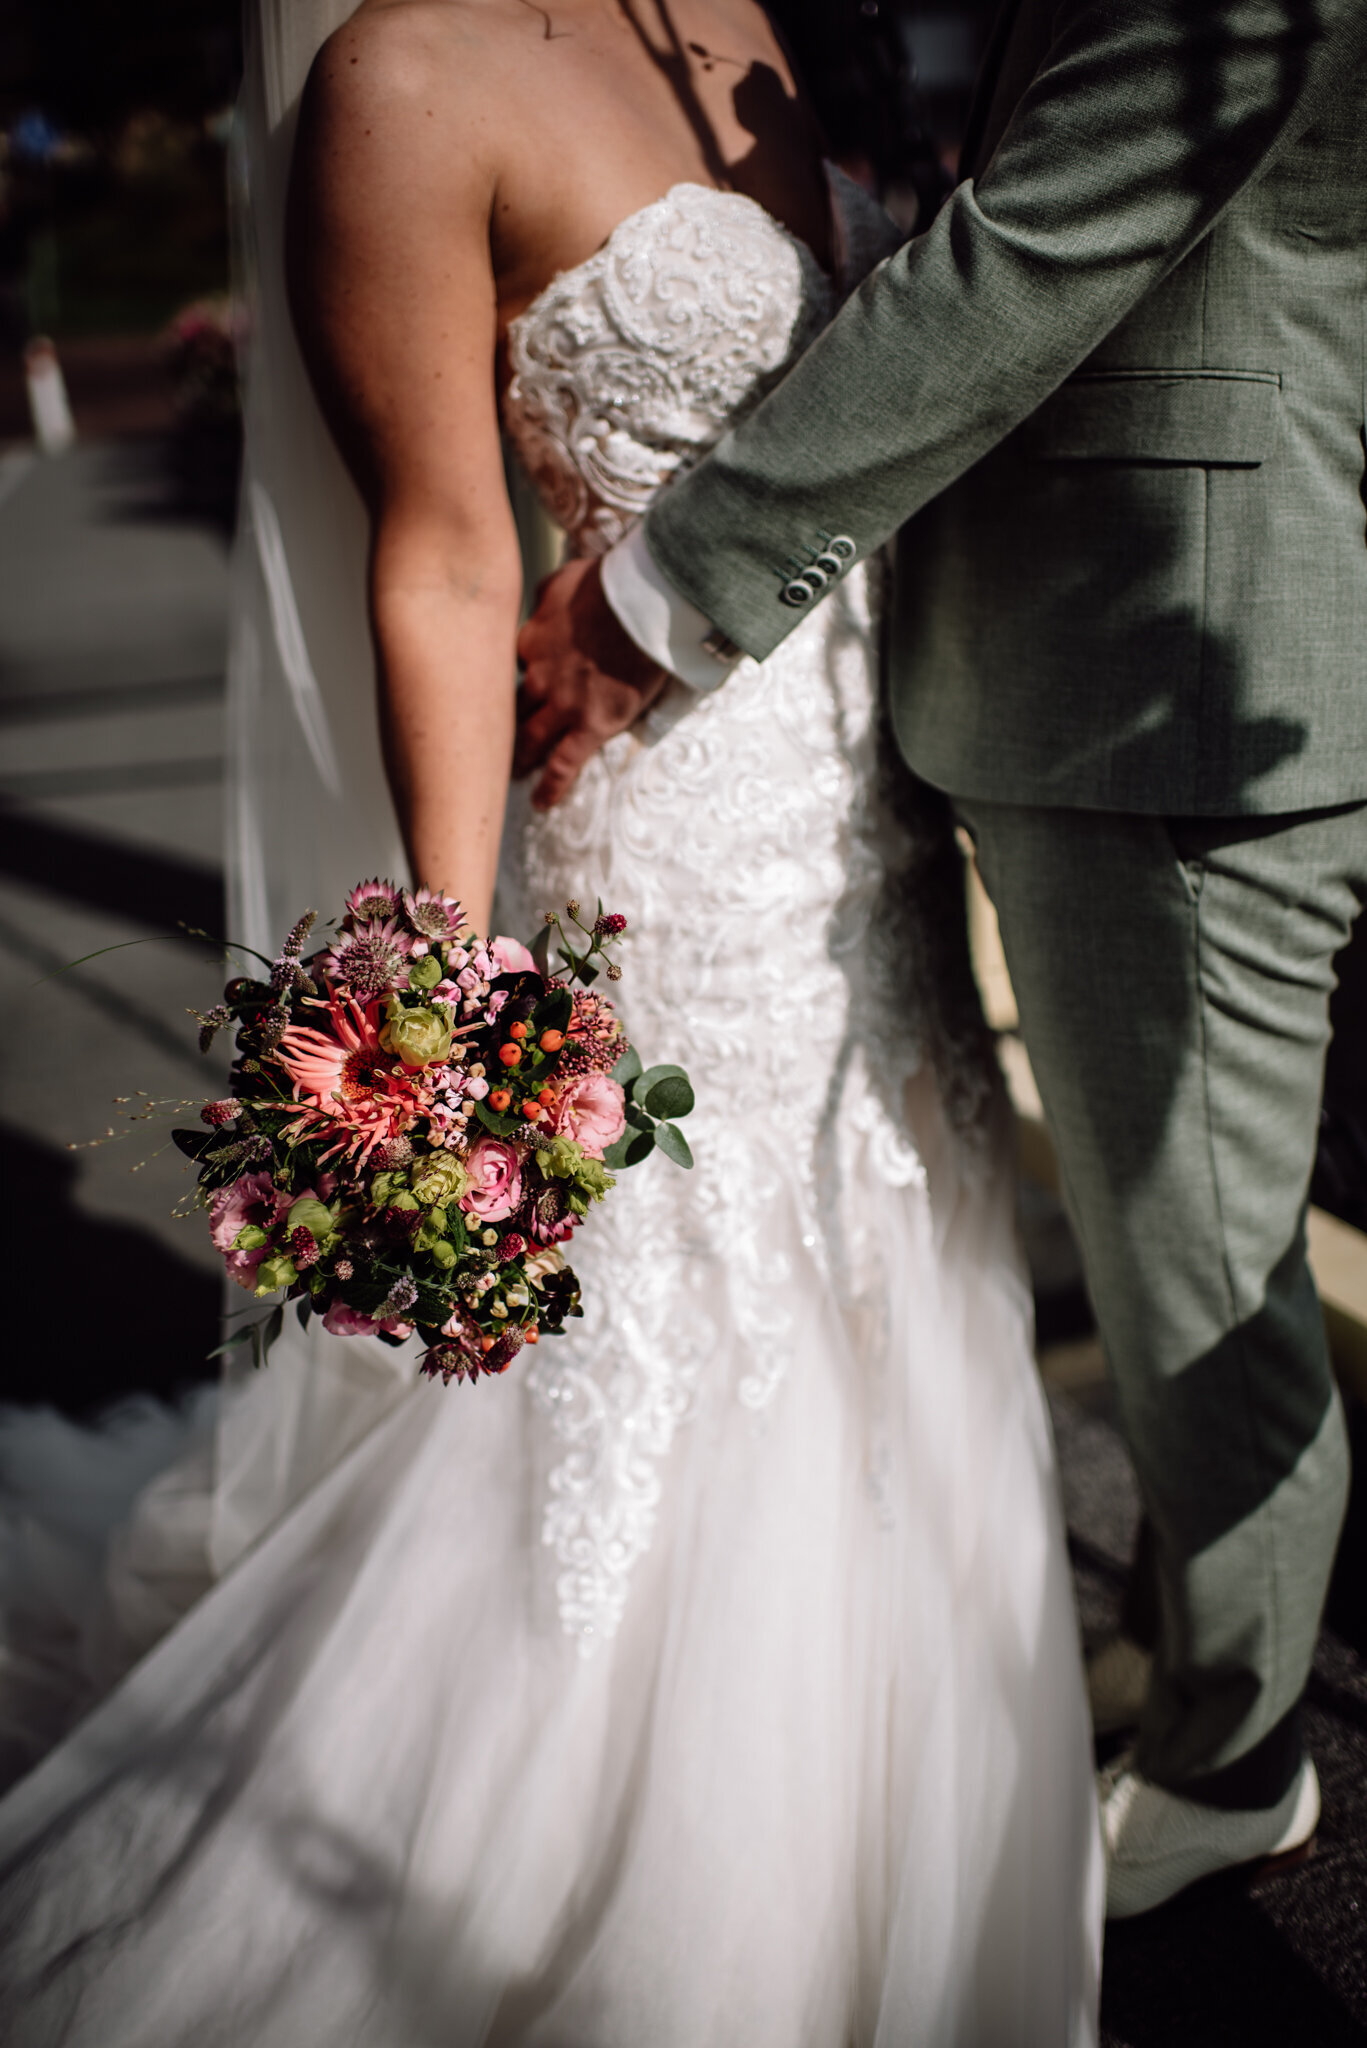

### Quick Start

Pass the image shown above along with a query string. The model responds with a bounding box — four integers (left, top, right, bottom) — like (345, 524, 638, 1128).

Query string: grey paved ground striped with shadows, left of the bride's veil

(0, 442, 227, 1405)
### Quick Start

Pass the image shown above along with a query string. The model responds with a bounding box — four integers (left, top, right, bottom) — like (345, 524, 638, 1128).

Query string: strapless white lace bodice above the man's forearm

(504, 172, 881, 555)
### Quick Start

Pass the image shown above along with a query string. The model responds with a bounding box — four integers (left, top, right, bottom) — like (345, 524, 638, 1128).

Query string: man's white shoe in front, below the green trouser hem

(1096, 1755, 1320, 1919)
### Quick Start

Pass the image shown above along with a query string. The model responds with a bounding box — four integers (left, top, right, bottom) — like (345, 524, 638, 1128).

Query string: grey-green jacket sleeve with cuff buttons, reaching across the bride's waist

(646, 0, 1367, 657)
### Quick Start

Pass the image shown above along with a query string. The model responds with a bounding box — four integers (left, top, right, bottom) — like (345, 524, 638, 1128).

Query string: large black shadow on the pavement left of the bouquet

(0, 1126, 221, 1417)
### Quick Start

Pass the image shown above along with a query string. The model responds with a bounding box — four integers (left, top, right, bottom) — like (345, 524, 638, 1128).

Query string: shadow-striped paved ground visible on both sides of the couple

(0, 428, 1367, 2048)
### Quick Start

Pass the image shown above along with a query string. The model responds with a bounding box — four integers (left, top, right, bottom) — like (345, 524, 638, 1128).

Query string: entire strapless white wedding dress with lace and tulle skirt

(0, 144, 1101, 2048)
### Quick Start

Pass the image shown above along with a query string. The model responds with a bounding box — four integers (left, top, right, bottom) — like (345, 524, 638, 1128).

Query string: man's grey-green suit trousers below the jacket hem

(959, 803, 1367, 1806)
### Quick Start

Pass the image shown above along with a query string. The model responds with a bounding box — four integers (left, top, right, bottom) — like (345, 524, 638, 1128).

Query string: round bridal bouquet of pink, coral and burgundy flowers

(172, 881, 693, 1382)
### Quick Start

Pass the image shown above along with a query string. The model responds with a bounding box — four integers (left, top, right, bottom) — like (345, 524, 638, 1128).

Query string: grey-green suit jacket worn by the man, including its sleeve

(646, 0, 1367, 815)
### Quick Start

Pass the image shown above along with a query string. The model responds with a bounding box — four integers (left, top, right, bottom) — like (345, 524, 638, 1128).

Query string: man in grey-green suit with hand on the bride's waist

(519, 0, 1367, 1915)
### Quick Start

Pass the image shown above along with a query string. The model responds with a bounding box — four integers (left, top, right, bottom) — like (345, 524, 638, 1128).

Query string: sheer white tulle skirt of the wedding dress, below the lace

(0, 1081, 1101, 2048)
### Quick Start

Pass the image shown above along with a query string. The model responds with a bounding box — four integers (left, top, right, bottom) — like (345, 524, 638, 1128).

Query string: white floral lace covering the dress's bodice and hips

(500, 186, 992, 1651)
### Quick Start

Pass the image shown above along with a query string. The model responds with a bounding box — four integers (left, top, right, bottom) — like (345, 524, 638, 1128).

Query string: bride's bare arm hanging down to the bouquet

(289, 23, 521, 930)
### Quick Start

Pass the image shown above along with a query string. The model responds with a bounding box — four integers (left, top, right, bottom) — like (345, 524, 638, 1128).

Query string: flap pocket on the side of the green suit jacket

(1023, 371, 1281, 469)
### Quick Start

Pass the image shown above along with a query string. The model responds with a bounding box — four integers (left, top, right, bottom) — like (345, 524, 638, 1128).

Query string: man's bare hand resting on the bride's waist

(512, 561, 668, 811)
